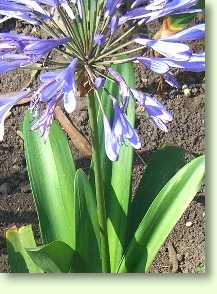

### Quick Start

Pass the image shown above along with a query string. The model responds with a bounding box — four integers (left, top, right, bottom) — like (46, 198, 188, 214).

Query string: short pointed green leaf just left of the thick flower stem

(75, 169, 101, 273)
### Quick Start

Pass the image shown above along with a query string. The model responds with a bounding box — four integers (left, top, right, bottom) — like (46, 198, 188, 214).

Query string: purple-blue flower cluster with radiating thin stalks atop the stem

(0, 0, 205, 160)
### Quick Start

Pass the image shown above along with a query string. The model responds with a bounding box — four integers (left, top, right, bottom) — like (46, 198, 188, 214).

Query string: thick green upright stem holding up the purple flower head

(88, 90, 110, 273)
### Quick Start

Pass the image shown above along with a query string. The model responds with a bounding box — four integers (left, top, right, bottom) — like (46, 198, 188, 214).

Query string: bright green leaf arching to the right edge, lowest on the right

(118, 156, 205, 273)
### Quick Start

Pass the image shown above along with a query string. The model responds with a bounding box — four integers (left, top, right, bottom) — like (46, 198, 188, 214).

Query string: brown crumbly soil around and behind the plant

(0, 19, 205, 273)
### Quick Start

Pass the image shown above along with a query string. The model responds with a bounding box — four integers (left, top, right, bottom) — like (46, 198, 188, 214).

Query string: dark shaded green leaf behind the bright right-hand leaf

(129, 146, 186, 241)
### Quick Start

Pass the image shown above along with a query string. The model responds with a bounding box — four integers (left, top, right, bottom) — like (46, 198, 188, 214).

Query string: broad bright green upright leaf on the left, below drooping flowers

(23, 113, 76, 247)
